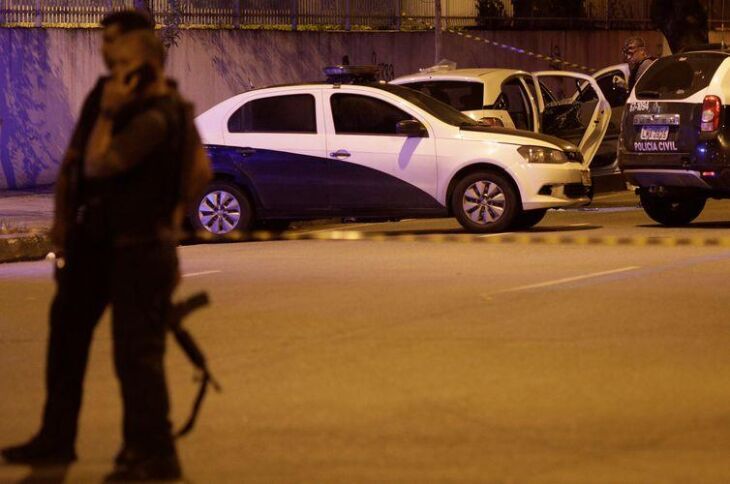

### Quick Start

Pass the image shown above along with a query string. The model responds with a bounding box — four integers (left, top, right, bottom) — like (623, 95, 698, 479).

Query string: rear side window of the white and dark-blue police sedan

(228, 94, 317, 133)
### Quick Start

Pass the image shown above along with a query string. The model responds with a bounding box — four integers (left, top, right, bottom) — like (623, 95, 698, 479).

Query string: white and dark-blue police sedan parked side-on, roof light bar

(190, 66, 590, 235)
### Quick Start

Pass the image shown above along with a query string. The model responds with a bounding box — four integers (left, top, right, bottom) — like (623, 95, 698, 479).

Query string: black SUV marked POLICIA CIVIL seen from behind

(618, 50, 730, 226)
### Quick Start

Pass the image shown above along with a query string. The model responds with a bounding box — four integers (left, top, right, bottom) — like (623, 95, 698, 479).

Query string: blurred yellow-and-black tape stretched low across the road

(195, 230, 730, 247)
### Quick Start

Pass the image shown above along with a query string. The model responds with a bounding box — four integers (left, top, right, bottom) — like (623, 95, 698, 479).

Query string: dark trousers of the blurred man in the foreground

(41, 243, 178, 455)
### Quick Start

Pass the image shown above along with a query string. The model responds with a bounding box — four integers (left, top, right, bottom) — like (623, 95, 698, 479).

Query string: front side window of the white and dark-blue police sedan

(330, 94, 413, 135)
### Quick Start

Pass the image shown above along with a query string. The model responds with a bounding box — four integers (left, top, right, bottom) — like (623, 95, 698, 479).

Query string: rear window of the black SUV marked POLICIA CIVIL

(636, 52, 728, 99)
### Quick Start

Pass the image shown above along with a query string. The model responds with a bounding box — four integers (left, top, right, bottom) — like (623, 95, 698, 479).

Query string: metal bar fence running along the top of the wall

(0, 0, 730, 30)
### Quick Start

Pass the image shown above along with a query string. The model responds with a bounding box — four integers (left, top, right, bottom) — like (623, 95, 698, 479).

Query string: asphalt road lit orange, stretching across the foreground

(0, 191, 730, 483)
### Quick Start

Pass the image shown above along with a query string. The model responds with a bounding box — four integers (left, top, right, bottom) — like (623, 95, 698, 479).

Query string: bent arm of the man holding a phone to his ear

(84, 110, 167, 178)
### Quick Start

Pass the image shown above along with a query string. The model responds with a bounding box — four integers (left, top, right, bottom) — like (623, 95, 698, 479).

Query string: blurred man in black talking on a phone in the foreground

(2, 17, 210, 481)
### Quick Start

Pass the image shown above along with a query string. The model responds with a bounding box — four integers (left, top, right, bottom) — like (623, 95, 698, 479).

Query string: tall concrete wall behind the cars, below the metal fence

(0, 28, 662, 188)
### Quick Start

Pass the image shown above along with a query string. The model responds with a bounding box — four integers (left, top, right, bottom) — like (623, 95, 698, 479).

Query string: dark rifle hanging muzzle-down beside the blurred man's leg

(167, 292, 221, 438)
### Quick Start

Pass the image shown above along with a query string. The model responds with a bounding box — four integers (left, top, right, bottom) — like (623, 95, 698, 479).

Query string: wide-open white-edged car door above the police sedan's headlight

(534, 71, 611, 166)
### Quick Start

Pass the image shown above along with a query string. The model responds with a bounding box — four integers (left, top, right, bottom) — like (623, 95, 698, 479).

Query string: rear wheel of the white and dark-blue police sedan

(192, 182, 252, 235)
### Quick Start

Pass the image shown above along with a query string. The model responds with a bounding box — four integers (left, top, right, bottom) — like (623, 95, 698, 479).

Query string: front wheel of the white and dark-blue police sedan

(451, 171, 519, 233)
